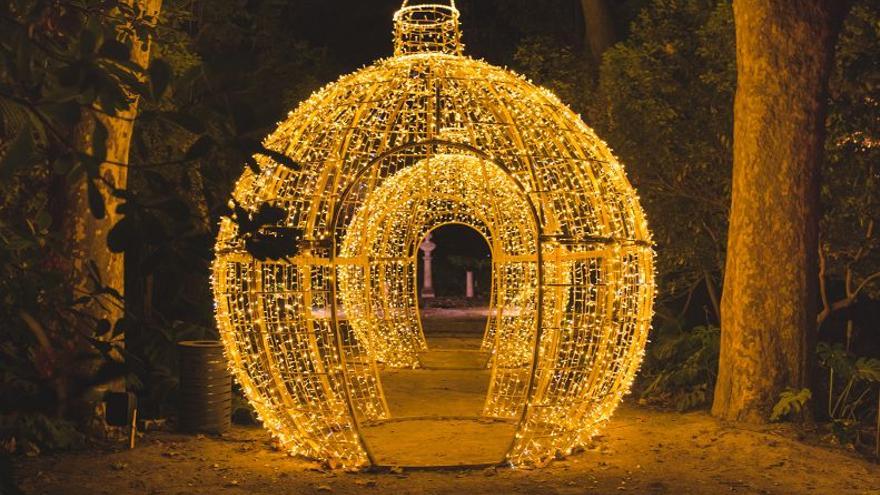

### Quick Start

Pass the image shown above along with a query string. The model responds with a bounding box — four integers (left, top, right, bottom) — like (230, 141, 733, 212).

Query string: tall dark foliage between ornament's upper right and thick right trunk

(587, 0, 736, 310)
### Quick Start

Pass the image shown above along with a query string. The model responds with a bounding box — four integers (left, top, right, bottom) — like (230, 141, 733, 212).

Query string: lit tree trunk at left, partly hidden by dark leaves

(67, 0, 162, 338)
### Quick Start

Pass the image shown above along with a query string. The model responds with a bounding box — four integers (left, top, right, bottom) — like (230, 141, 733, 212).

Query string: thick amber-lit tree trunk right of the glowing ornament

(712, 0, 845, 423)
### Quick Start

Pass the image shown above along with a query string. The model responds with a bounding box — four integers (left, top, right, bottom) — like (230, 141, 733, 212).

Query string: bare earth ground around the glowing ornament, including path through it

(10, 315, 880, 495)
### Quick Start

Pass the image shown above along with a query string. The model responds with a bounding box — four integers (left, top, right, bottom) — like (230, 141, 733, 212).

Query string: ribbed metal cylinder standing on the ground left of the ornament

(177, 340, 232, 433)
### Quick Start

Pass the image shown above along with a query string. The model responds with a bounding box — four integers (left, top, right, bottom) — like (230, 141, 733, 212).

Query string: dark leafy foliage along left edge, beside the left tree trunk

(0, 0, 169, 448)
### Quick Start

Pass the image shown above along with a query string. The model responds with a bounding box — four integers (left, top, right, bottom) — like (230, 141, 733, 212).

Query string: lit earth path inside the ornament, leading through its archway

(363, 319, 516, 467)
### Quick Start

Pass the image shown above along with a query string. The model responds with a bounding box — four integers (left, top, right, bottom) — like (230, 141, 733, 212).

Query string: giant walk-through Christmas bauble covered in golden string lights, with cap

(213, 2, 654, 467)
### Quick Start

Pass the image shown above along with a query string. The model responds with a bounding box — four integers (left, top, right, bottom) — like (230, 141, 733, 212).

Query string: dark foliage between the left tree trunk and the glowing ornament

(117, 1, 331, 409)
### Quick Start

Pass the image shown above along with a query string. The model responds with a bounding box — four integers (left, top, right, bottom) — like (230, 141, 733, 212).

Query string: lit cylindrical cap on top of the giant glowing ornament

(394, 0, 464, 56)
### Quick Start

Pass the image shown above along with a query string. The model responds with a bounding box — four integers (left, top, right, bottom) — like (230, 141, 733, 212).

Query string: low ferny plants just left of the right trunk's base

(638, 325, 721, 411)
